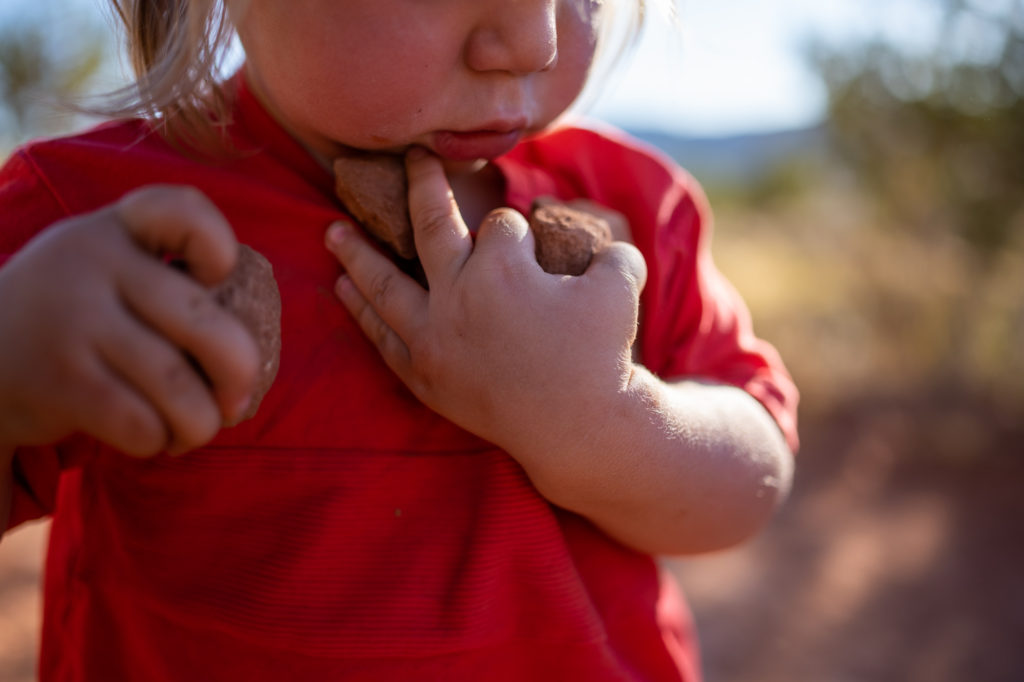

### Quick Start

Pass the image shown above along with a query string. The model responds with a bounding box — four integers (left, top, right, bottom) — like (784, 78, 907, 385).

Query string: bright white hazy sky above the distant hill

(0, 0, 950, 136)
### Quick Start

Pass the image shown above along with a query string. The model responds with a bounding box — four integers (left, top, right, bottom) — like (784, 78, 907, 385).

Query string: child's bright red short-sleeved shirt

(0, 75, 796, 682)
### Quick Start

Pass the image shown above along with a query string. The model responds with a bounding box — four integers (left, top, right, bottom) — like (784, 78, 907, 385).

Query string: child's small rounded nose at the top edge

(465, 0, 558, 75)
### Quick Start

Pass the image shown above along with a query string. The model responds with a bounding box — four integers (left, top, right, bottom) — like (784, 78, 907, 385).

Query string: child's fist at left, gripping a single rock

(0, 186, 259, 455)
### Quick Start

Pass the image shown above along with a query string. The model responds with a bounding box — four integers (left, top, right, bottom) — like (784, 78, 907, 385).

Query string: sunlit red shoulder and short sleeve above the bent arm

(456, 126, 798, 451)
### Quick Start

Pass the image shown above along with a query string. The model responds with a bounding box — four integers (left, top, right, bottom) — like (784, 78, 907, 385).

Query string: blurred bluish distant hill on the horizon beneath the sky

(629, 126, 827, 182)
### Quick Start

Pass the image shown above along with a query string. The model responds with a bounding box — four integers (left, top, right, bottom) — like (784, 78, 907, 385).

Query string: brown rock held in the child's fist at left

(213, 244, 281, 422)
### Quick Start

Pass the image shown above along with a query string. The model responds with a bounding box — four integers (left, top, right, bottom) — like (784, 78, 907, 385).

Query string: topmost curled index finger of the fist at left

(115, 185, 238, 285)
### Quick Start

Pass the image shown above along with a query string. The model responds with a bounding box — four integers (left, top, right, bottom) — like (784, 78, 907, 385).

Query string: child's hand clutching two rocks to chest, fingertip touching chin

(328, 152, 646, 456)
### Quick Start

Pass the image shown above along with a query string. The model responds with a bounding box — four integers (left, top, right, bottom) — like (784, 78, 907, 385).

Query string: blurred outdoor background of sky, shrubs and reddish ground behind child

(0, 0, 1024, 682)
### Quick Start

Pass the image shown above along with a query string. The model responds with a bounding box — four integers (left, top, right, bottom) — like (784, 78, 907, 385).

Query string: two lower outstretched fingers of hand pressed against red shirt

(327, 222, 427, 345)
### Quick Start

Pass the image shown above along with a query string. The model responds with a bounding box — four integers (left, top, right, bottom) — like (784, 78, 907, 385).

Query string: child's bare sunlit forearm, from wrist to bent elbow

(519, 368, 793, 554)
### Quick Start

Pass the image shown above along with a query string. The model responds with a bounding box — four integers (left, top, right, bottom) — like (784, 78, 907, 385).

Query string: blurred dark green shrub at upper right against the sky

(811, 0, 1024, 258)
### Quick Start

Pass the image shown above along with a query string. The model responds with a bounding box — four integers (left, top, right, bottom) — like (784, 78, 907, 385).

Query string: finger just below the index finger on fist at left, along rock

(118, 259, 260, 422)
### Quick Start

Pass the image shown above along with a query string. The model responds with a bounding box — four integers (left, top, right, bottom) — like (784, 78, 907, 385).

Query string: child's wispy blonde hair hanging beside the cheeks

(103, 0, 655, 151)
